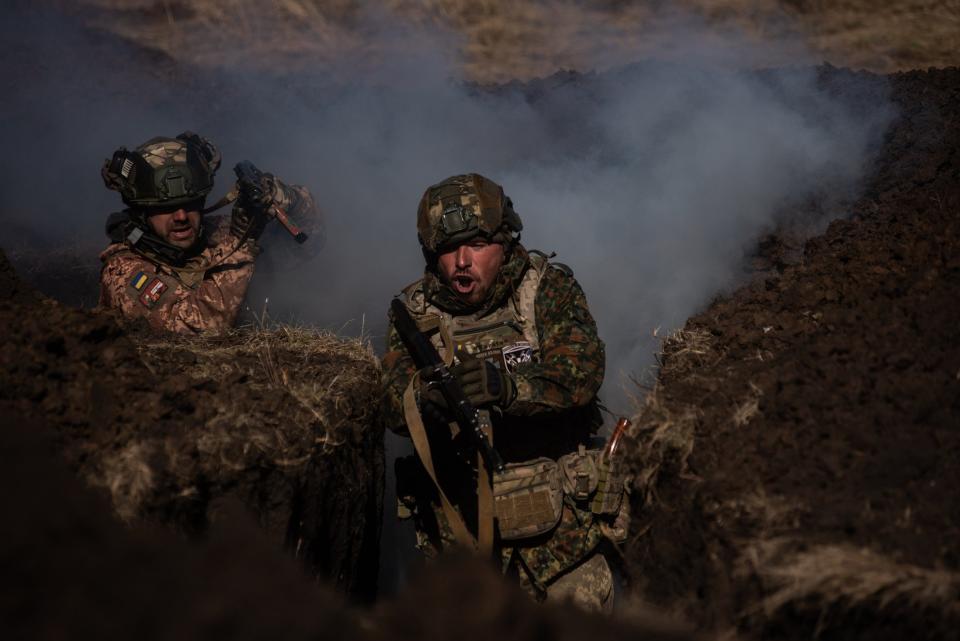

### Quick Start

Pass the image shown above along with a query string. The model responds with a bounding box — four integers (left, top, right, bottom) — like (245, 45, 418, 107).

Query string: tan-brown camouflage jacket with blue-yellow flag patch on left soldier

(100, 236, 254, 333)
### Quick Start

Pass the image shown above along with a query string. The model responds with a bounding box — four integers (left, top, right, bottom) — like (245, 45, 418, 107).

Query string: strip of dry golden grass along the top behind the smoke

(47, 0, 960, 82)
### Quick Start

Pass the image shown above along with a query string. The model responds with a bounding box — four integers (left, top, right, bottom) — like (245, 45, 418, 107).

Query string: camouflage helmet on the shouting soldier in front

(417, 174, 523, 254)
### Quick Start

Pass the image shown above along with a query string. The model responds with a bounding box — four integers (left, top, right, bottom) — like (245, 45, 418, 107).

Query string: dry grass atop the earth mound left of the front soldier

(98, 326, 380, 519)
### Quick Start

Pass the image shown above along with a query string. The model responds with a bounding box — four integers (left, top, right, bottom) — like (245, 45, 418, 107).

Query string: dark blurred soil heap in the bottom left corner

(0, 411, 360, 641)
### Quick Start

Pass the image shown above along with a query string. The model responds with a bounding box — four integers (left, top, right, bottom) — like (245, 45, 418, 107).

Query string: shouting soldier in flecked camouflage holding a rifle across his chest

(383, 174, 627, 611)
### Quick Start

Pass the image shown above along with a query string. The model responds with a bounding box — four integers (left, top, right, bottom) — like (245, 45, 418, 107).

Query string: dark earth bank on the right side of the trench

(627, 69, 960, 639)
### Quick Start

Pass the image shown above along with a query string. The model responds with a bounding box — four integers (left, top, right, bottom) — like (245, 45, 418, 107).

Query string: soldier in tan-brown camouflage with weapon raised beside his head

(100, 132, 323, 333)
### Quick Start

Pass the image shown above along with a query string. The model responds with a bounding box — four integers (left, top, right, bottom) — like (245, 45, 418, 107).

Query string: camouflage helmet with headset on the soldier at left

(100, 131, 220, 209)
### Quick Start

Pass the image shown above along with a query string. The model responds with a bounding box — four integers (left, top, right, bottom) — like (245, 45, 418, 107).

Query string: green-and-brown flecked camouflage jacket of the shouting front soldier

(383, 246, 605, 588)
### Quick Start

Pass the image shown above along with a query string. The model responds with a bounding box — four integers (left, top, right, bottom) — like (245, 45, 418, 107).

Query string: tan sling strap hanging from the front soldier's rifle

(403, 374, 493, 556)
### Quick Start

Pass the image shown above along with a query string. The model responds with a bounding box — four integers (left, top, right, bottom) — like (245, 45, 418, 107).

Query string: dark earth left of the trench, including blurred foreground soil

(0, 272, 697, 641)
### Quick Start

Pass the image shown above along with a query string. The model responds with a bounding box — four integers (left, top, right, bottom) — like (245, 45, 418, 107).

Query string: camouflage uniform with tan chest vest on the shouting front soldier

(383, 174, 612, 611)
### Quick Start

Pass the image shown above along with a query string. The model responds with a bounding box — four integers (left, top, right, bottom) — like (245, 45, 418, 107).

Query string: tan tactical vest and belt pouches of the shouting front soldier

(397, 252, 624, 548)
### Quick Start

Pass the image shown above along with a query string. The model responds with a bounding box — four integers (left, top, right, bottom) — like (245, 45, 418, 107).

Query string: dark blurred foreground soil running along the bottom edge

(0, 380, 696, 641)
